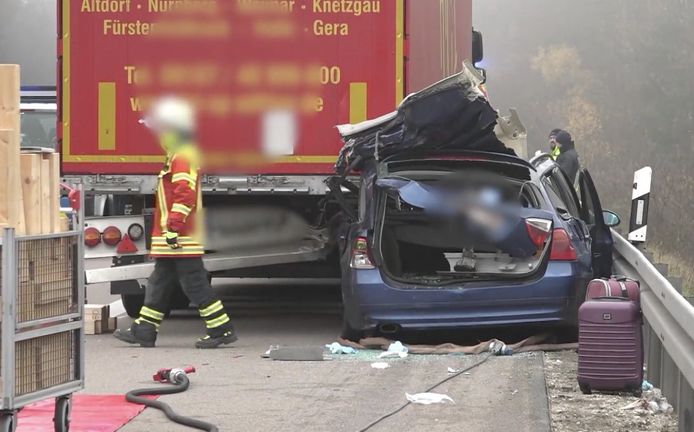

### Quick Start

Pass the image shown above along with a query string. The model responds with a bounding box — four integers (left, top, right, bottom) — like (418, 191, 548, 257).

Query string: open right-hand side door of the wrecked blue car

(578, 168, 612, 277)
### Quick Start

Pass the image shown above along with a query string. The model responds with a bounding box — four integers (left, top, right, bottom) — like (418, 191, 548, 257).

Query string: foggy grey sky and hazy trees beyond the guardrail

(473, 0, 694, 296)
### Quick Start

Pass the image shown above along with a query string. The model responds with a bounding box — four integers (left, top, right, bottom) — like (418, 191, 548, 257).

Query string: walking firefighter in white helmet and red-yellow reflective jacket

(114, 98, 237, 348)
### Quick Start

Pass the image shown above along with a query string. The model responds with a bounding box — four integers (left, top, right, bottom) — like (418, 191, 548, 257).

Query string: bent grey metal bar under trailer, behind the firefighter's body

(85, 239, 329, 284)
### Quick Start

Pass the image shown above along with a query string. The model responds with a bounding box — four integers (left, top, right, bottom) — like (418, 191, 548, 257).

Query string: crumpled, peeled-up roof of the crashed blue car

(335, 62, 515, 175)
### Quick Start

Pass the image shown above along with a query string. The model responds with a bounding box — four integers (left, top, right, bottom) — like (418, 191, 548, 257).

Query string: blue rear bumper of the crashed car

(343, 262, 587, 330)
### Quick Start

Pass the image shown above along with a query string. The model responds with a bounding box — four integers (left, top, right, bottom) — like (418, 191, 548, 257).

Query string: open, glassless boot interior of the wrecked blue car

(376, 163, 549, 285)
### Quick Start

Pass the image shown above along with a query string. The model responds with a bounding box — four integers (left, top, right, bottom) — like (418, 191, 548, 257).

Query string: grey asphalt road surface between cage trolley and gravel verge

(85, 280, 549, 432)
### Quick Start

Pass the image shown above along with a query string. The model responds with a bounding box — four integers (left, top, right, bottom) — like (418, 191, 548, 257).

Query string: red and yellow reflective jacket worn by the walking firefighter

(150, 144, 205, 258)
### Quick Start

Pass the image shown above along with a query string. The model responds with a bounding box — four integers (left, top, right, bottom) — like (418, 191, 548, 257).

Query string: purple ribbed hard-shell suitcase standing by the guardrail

(578, 279, 643, 395)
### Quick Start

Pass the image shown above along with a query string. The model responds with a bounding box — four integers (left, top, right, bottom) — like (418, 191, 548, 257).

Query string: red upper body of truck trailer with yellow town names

(58, 0, 471, 175)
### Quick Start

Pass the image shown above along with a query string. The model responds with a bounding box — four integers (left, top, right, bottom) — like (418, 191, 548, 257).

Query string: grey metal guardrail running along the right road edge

(612, 231, 694, 432)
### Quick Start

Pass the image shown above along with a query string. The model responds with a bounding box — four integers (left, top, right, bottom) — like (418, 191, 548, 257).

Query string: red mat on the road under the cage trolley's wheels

(17, 394, 156, 432)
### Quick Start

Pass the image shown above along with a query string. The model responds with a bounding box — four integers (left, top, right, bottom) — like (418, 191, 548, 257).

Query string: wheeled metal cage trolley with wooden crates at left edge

(0, 212, 85, 432)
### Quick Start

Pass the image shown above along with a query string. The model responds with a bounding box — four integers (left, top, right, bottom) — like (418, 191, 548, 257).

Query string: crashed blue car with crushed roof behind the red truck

(329, 66, 619, 339)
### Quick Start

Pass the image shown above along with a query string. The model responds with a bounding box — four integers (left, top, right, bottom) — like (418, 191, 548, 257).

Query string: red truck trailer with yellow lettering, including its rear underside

(58, 0, 482, 313)
